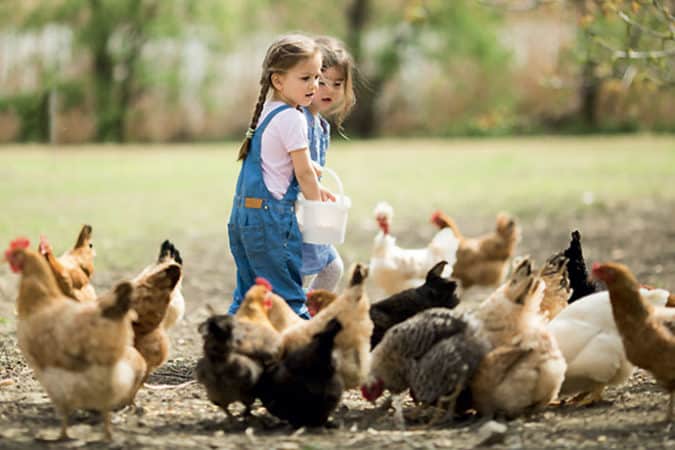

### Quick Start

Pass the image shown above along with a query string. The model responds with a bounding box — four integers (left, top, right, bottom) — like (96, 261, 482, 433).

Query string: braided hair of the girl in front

(237, 34, 320, 161)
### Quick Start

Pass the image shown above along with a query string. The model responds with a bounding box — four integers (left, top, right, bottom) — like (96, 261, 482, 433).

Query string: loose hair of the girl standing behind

(314, 36, 356, 132)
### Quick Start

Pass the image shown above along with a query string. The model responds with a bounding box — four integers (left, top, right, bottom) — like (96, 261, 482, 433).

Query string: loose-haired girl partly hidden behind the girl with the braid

(301, 36, 354, 291)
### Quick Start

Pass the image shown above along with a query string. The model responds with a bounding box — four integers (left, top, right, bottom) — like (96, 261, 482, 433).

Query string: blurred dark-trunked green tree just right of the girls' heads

(345, 0, 508, 137)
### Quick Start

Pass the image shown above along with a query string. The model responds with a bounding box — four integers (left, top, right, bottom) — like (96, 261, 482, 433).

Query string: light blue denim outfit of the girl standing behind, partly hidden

(300, 108, 337, 276)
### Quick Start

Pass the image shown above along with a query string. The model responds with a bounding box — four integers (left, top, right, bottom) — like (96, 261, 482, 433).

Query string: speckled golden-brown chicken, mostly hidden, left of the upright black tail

(539, 252, 572, 321)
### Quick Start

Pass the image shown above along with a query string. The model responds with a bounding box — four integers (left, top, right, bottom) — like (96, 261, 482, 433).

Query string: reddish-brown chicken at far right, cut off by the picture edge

(593, 263, 675, 422)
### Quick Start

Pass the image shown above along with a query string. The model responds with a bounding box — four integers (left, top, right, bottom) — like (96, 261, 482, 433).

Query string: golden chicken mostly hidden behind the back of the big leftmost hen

(39, 225, 96, 302)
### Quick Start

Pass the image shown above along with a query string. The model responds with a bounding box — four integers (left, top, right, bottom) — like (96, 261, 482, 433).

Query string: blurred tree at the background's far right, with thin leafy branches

(478, 0, 675, 130)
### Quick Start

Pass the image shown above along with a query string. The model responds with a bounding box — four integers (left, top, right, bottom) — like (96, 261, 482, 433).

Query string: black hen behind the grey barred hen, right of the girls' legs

(370, 261, 459, 350)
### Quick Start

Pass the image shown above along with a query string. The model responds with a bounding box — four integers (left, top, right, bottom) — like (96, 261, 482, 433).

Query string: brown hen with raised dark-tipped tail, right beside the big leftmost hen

(132, 259, 182, 381)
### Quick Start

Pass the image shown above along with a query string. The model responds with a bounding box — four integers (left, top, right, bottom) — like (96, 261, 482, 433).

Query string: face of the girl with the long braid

(272, 53, 321, 107)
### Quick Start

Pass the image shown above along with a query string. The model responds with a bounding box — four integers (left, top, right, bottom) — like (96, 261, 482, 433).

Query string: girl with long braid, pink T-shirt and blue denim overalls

(228, 35, 335, 318)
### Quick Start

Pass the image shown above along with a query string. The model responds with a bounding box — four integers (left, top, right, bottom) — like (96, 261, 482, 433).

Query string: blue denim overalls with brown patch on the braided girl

(227, 105, 309, 319)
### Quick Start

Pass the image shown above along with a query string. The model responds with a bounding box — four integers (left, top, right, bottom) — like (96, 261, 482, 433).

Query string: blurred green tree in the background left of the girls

(0, 0, 242, 141)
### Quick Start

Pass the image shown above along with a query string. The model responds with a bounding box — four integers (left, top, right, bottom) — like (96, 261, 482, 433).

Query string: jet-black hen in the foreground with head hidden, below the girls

(255, 319, 343, 427)
